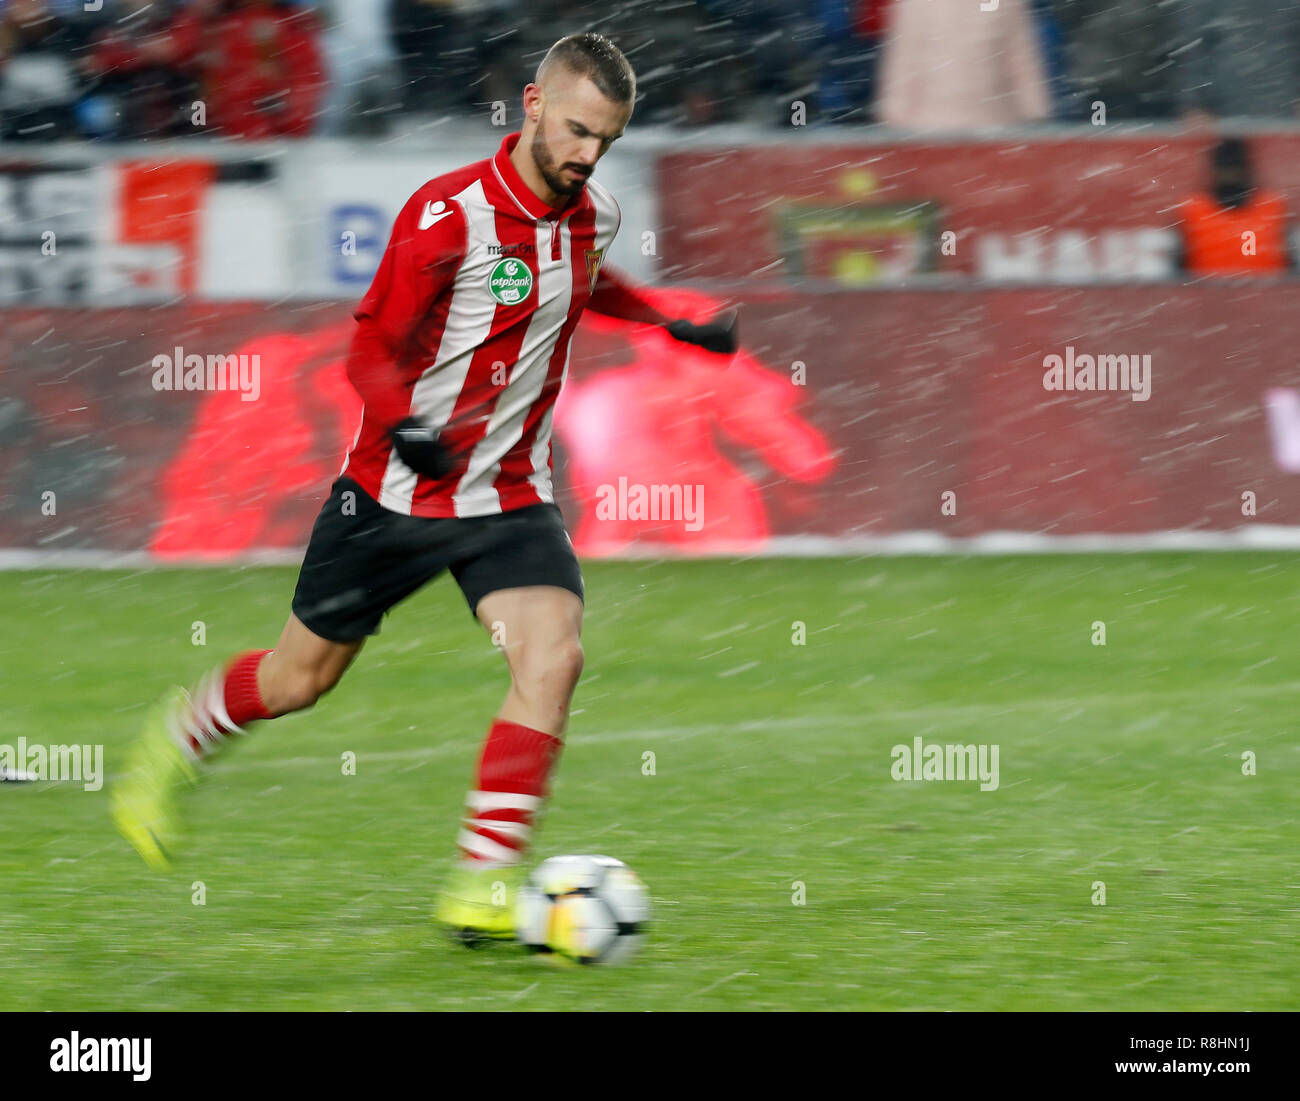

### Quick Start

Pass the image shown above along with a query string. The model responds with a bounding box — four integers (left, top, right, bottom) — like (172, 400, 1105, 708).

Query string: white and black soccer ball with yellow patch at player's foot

(515, 857, 650, 963)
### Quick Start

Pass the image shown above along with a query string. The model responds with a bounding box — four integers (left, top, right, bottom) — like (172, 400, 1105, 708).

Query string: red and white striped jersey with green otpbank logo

(343, 133, 621, 516)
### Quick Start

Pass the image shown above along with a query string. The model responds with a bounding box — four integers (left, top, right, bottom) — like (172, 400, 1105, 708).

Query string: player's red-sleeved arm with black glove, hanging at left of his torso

(347, 195, 465, 477)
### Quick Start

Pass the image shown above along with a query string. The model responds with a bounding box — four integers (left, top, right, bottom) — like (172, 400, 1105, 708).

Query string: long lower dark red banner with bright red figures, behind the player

(0, 282, 1300, 559)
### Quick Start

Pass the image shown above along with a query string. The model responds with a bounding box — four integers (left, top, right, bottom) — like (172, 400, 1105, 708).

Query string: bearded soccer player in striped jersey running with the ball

(112, 34, 736, 941)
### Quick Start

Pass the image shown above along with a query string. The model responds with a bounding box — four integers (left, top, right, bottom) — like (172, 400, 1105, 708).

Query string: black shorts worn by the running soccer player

(294, 474, 582, 642)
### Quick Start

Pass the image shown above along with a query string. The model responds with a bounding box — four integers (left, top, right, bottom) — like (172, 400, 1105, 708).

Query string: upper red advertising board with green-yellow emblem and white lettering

(657, 127, 1300, 286)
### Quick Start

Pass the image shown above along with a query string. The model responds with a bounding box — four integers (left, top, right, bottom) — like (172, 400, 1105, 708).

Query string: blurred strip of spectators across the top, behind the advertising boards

(0, 0, 1300, 140)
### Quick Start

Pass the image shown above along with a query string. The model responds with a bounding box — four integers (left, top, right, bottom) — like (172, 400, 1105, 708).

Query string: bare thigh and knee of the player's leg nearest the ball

(475, 585, 582, 679)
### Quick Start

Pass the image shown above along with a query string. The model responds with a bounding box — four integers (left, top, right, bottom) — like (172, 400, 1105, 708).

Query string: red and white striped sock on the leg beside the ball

(456, 719, 564, 864)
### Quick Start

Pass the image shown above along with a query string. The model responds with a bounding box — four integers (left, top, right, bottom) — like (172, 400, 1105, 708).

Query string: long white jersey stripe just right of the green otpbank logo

(452, 218, 573, 516)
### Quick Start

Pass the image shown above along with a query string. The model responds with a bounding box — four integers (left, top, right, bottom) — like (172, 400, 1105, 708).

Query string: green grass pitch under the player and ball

(0, 552, 1300, 1010)
